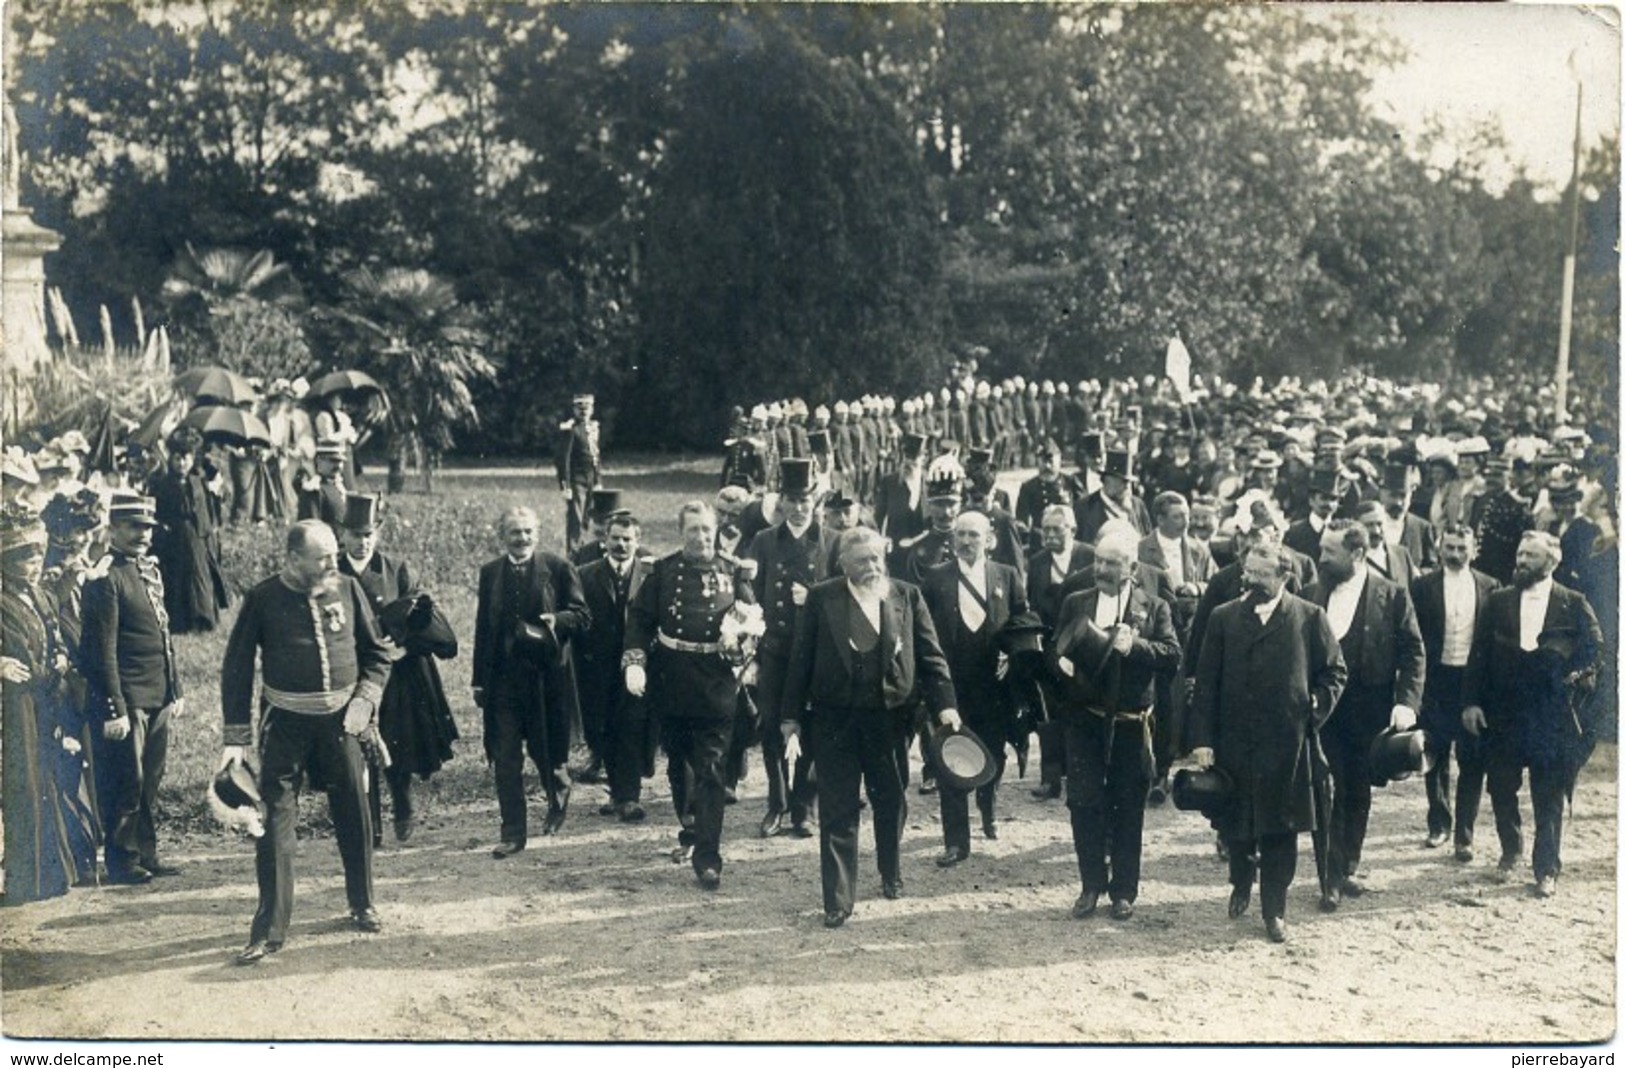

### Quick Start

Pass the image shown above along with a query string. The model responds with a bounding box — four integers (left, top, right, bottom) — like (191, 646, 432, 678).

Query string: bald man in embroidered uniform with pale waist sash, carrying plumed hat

(221, 519, 390, 964)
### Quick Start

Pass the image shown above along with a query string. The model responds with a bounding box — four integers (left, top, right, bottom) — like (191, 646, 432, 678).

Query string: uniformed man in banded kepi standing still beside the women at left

(81, 491, 184, 883)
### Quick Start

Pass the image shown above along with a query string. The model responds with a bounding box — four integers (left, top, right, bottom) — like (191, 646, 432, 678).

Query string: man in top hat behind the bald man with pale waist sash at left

(338, 493, 457, 845)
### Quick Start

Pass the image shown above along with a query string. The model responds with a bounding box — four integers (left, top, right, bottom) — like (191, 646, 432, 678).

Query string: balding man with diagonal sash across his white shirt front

(921, 512, 1027, 868)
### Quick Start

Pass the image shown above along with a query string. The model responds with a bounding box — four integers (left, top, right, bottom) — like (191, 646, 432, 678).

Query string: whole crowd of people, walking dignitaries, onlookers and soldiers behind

(0, 363, 1617, 964)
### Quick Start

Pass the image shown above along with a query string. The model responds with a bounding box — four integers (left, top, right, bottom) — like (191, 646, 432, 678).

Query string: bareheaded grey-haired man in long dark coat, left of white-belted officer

(473, 507, 590, 858)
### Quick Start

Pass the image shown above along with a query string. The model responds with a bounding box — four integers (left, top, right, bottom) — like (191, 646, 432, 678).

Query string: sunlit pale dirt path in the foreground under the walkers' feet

(0, 746, 1617, 1044)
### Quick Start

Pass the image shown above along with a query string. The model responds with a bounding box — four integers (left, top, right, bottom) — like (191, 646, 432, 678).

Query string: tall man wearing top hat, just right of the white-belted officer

(746, 458, 829, 837)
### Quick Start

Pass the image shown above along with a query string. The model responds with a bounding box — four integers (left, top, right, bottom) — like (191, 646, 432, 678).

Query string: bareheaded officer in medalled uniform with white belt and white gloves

(621, 501, 752, 891)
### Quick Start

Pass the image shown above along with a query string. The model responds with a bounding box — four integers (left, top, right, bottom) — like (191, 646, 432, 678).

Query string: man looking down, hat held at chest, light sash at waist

(1051, 530, 1180, 920)
